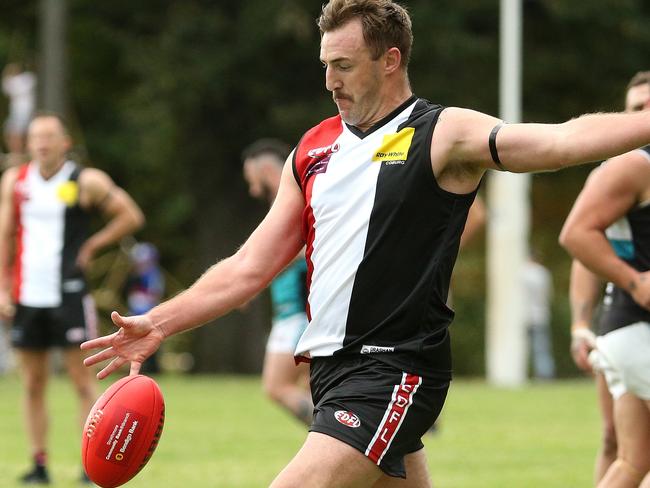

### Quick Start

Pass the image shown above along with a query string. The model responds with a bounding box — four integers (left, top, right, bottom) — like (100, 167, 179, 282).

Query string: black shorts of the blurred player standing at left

(11, 293, 97, 349)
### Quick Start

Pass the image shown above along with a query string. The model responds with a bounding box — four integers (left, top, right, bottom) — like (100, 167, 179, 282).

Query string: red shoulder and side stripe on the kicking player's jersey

(294, 115, 343, 320)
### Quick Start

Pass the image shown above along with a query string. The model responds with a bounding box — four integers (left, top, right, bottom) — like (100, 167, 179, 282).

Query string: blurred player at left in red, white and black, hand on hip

(0, 113, 143, 484)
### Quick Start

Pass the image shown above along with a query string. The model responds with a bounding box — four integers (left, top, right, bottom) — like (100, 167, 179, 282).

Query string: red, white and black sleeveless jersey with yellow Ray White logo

(293, 96, 476, 378)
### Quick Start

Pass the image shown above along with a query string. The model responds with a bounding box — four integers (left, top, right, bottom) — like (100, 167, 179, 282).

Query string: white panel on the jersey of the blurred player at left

(19, 162, 74, 307)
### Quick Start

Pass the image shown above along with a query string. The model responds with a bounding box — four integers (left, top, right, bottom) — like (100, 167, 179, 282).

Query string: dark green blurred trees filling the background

(0, 0, 650, 375)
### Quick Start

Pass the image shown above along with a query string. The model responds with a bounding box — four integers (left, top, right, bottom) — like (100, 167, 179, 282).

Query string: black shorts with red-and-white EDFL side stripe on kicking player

(310, 356, 449, 478)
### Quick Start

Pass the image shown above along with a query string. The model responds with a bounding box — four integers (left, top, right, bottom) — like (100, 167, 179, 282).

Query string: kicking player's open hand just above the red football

(81, 312, 165, 379)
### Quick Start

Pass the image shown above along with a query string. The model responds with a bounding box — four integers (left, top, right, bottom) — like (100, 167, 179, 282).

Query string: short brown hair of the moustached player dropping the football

(317, 0, 413, 69)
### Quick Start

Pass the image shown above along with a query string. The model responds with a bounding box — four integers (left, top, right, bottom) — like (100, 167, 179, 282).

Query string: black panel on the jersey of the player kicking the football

(335, 99, 476, 378)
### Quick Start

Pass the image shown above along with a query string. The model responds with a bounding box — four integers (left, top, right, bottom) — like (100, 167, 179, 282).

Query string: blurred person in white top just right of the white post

(522, 250, 555, 380)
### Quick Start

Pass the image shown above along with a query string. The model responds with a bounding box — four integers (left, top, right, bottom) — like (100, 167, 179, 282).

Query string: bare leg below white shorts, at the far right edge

(598, 393, 650, 488)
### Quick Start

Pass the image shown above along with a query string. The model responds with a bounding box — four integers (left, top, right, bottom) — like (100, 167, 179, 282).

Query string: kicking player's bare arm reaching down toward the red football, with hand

(82, 156, 304, 378)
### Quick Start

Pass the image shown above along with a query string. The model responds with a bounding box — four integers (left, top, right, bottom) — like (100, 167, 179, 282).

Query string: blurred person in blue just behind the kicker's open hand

(126, 242, 165, 374)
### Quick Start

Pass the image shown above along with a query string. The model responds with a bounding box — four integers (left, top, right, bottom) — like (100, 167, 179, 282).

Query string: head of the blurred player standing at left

(27, 117, 70, 166)
